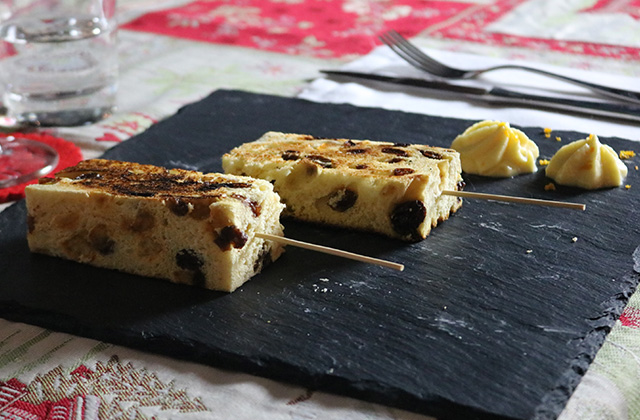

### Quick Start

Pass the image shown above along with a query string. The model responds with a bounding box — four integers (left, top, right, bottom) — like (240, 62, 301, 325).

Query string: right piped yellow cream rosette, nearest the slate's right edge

(546, 134, 628, 190)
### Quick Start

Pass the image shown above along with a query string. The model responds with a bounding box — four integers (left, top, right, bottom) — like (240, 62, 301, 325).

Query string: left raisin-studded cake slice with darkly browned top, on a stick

(25, 159, 283, 292)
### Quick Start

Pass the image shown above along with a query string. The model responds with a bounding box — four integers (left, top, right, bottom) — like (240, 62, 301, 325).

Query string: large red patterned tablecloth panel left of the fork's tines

(123, 0, 471, 57)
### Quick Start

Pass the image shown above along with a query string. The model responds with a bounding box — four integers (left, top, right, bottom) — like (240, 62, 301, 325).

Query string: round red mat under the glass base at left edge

(0, 133, 82, 203)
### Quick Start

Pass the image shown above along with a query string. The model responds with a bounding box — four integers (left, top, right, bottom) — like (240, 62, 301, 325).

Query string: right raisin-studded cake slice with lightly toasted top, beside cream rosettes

(222, 132, 463, 241)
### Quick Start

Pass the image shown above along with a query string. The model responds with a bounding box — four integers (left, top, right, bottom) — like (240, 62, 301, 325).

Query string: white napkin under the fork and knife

(299, 46, 640, 141)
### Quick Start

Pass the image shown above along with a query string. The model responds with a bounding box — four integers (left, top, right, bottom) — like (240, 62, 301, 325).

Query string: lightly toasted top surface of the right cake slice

(228, 132, 458, 177)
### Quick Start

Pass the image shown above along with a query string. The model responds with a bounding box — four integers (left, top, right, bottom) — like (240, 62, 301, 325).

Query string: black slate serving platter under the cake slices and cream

(0, 91, 640, 419)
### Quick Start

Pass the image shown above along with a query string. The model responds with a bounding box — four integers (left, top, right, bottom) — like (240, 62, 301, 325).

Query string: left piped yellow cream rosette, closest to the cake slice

(451, 120, 540, 178)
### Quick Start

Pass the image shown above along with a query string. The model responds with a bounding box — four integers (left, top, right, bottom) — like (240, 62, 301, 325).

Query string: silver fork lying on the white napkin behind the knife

(379, 30, 640, 103)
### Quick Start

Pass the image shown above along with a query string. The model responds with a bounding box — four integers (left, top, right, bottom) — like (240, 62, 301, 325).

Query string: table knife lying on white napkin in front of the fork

(320, 70, 640, 123)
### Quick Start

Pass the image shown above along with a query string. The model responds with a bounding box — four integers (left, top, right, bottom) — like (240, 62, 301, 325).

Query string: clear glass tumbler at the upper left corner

(0, 0, 118, 126)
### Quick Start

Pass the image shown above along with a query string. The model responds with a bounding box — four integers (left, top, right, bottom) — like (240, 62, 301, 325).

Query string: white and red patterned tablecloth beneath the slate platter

(0, 0, 640, 420)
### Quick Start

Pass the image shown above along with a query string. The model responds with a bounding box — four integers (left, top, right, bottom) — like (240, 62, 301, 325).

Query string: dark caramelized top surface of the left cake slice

(39, 159, 254, 198)
